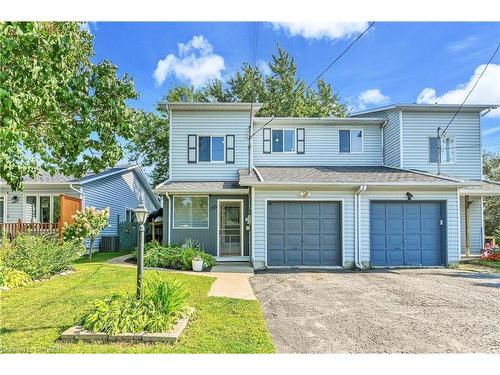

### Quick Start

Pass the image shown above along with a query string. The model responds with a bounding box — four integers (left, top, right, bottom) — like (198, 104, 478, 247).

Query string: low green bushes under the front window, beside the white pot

(136, 240, 216, 271)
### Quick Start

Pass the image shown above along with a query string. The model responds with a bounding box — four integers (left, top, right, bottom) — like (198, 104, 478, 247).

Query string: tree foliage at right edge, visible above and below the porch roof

(483, 152, 500, 240)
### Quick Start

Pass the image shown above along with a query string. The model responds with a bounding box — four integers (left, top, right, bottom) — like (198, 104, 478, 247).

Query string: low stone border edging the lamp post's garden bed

(61, 307, 195, 343)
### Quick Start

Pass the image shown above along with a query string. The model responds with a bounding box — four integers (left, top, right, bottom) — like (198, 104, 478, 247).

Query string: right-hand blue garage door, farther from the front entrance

(370, 201, 445, 266)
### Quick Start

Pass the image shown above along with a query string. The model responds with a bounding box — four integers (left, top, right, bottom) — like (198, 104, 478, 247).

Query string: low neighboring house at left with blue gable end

(0, 165, 160, 248)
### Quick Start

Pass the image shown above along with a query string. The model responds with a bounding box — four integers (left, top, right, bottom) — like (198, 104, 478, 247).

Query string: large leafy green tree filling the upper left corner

(0, 22, 148, 190)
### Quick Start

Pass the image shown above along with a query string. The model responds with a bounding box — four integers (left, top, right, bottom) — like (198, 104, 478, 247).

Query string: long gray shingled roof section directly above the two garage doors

(239, 166, 460, 186)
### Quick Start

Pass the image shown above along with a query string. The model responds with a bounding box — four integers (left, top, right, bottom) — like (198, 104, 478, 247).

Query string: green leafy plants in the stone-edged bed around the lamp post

(80, 277, 189, 335)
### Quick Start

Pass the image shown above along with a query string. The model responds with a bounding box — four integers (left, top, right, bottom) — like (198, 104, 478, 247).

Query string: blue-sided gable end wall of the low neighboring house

(83, 170, 159, 249)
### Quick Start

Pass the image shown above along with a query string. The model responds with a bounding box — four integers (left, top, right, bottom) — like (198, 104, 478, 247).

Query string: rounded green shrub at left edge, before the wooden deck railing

(0, 234, 81, 279)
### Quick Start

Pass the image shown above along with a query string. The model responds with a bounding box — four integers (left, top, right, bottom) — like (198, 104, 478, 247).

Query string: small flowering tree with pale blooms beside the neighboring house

(63, 207, 109, 262)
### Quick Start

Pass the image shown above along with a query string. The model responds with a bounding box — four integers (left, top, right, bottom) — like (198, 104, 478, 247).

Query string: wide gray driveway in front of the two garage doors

(250, 269, 500, 353)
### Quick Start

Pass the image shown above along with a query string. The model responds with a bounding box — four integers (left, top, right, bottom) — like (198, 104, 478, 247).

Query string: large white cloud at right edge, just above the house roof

(417, 64, 500, 117)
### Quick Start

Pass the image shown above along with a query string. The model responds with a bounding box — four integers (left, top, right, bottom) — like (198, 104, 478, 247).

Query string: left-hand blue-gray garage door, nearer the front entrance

(267, 201, 342, 266)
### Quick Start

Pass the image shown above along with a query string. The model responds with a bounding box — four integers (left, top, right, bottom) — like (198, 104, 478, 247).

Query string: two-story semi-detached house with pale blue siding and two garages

(156, 103, 500, 268)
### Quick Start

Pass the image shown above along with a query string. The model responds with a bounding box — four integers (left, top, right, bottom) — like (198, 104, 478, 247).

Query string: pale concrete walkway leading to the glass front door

(106, 254, 257, 300)
